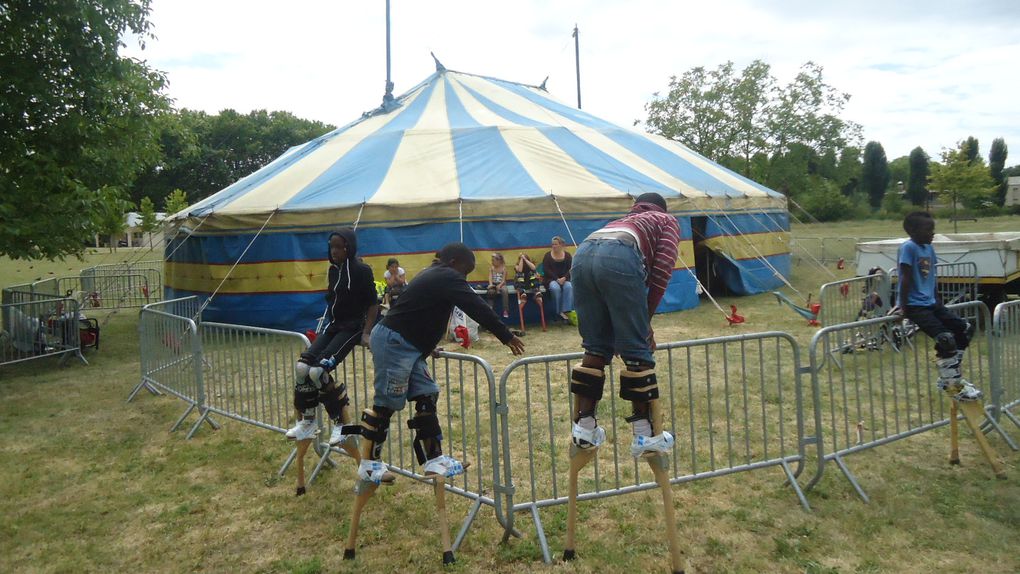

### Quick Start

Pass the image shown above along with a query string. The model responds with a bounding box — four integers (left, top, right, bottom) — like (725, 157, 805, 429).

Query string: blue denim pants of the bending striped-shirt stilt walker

(570, 239, 655, 365)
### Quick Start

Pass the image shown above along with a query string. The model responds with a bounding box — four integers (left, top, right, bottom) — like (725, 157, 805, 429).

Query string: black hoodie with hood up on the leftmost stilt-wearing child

(325, 227, 378, 329)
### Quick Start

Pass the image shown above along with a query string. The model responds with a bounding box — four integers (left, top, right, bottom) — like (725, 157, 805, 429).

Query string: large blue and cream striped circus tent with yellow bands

(165, 67, 789, 330)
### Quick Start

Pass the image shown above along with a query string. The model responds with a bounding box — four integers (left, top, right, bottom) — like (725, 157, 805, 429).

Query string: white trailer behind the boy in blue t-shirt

(857, 231, 1020, 307)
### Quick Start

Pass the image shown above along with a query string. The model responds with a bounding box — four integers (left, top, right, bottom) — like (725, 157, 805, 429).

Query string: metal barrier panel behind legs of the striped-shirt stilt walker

(498, 332, 814, 562)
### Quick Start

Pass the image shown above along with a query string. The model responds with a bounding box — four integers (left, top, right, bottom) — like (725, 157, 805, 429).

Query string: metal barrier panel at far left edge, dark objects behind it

(0, 291, 88, 366)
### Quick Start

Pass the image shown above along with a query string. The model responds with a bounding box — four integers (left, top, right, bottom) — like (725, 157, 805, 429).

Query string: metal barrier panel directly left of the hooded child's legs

(196, 322, 308, 436)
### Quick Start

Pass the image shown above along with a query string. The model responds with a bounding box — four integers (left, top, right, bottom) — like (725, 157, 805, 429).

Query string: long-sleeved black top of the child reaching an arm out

(381, 265, 513, 354)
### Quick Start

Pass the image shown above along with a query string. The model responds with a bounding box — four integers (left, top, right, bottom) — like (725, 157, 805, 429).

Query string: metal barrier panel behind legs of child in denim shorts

(326, 347, 503, 551)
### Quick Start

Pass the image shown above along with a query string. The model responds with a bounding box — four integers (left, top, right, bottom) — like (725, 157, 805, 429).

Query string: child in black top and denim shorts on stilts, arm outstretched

(344, 243, 524, 564)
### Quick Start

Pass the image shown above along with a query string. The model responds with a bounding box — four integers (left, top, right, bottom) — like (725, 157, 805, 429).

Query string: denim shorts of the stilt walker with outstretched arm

(371, 323, 440, 411)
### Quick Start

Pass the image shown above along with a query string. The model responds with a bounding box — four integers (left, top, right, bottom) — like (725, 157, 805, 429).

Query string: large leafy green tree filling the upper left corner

(0, 0, 168, 259)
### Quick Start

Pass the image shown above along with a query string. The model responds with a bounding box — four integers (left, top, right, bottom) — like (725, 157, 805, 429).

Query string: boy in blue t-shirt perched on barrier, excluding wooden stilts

(897, 211, 981, 401)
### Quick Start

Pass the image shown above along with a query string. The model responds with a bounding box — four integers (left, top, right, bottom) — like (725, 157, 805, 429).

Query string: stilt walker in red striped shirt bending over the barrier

(563, 193, 682, 572)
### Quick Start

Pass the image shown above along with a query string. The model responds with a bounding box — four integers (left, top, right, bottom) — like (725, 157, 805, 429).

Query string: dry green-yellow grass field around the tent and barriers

(0, 217, 1020, 573)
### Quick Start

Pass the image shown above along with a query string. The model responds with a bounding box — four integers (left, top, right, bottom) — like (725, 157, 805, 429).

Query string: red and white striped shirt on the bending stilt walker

(603, 203, 680, 315)
